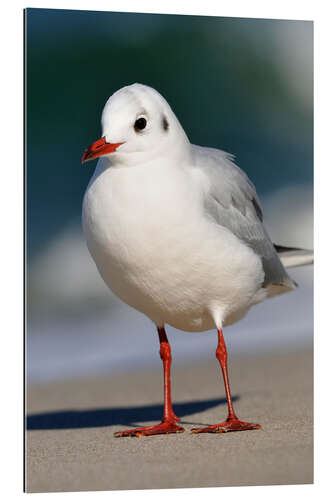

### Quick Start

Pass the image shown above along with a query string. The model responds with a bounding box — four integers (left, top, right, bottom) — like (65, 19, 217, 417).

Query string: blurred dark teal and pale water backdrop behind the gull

(25, 9, 313, 382)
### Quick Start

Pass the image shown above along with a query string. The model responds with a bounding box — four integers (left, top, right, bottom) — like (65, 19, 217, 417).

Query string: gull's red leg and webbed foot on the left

(115, 327, 184, 437)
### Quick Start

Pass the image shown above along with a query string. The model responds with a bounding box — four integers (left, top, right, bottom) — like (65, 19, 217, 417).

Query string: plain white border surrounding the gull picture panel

(0, 0, 333, 500)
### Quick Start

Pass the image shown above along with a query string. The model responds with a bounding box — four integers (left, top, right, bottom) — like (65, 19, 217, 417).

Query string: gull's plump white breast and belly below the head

(83, 160, 262, 331)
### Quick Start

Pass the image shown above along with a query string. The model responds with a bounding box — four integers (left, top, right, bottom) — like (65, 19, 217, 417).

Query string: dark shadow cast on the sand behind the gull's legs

(26, 396, 239, 430)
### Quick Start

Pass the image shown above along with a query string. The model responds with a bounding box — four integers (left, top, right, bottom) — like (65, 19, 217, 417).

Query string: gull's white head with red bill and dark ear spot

(82, 83, 190, 166)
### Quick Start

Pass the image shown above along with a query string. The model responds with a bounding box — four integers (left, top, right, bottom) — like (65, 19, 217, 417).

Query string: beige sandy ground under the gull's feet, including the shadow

(26, 350, 313, 492)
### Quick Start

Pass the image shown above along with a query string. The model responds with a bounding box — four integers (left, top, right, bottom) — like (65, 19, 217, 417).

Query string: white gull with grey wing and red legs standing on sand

(82, 83, 313, 437)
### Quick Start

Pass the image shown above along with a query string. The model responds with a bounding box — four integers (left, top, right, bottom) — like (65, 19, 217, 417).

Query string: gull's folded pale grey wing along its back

(193, 146, 295, 288)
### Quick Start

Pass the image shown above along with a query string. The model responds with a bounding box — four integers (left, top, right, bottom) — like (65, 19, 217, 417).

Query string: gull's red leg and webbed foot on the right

(192, 329, 261, 434)
